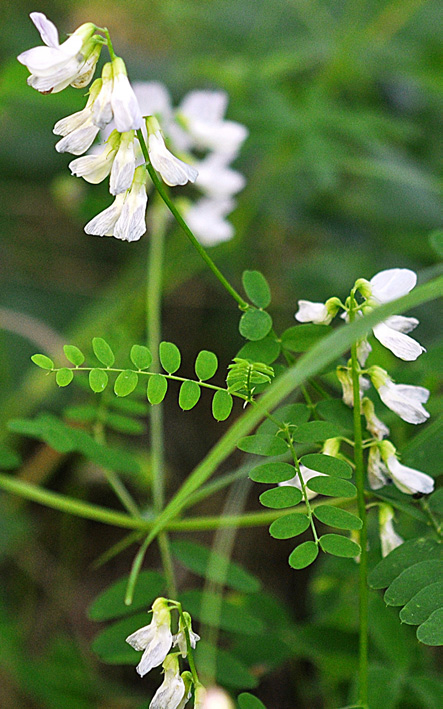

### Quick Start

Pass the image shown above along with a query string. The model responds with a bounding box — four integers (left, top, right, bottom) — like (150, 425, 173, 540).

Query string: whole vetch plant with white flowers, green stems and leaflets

(0, 13, 443, 709)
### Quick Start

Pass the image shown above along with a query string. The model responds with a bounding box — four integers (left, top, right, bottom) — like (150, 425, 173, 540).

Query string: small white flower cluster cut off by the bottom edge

(126, 598, 204, 709)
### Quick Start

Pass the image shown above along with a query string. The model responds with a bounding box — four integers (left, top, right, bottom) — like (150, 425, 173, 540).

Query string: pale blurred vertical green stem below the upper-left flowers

(146, 198, 177, 598)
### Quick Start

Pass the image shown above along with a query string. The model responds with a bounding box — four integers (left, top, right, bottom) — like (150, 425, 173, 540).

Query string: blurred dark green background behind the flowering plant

(0, 0, 441, 709)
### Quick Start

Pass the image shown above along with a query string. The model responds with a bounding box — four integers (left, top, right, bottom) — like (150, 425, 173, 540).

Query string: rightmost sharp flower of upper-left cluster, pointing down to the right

(146, 116, 198, 187)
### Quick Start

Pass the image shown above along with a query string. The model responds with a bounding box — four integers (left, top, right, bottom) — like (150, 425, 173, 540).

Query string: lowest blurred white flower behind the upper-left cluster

(185, 197, 235, 246)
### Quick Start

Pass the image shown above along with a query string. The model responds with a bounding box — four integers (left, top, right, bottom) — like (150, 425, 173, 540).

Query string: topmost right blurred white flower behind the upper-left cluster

(177, 91, 248, 158)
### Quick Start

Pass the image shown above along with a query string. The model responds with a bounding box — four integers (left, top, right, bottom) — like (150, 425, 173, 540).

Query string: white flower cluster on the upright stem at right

(295, 268, 434, 495)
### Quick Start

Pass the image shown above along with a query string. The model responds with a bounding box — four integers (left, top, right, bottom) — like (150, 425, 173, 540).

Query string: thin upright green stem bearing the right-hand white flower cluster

(349, 295, 368, 707)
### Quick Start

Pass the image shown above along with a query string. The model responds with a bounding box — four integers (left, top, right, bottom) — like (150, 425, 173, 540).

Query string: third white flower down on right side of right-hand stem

(369, 367, 429, 424)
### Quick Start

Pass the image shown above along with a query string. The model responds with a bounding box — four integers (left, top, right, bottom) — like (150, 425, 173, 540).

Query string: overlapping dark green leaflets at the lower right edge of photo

(369, 538, 443, 645)
